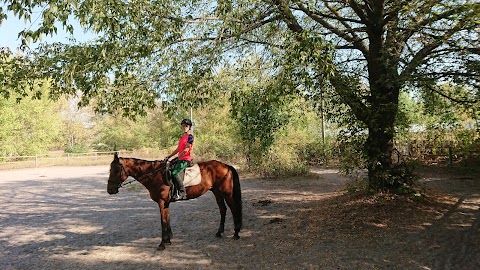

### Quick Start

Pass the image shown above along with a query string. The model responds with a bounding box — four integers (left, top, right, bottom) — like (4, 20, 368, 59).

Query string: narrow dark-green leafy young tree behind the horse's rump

(230, 58, 293, 167)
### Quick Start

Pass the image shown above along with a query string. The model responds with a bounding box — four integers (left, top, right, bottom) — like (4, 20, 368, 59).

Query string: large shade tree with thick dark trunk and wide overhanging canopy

(0, 0, 480, 188)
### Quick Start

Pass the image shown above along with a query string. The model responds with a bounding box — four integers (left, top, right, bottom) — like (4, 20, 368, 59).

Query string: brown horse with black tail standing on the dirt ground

(107, 154, 242, 250)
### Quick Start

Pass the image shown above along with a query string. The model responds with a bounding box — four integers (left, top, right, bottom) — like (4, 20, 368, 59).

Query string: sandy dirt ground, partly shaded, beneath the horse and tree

(0, 163, 480, 270)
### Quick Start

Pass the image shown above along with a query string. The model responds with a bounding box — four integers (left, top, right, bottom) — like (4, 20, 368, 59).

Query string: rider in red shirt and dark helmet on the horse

(165, 119, 193, 201)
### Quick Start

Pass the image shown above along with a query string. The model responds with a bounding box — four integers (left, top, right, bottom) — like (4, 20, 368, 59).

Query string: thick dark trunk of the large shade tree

(364, 14, 401, 189)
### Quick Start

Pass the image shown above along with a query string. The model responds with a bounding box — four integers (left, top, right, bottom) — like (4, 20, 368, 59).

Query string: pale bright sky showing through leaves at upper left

(0, 9, 95, 52)
